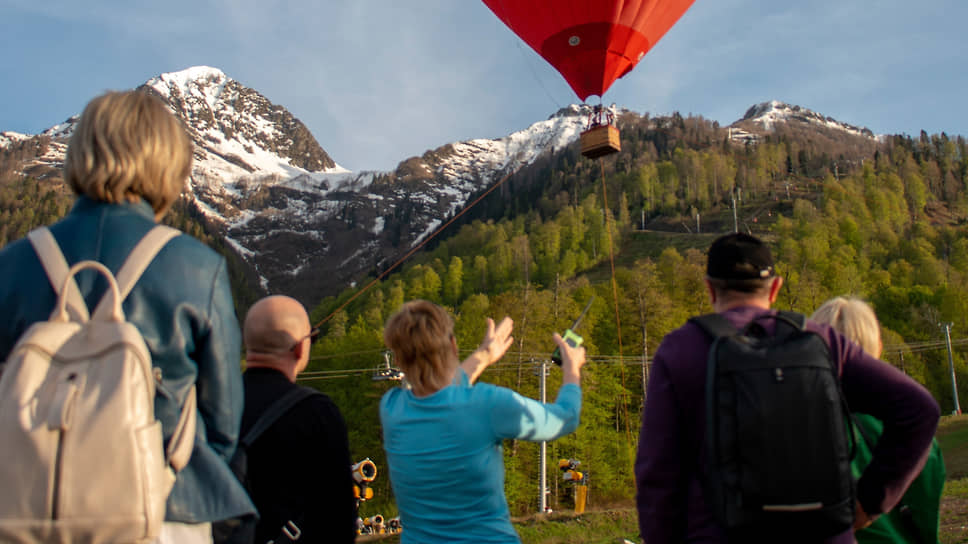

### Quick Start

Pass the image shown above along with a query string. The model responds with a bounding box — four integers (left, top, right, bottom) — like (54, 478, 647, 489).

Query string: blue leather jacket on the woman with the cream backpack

(0, 197, 255, 522)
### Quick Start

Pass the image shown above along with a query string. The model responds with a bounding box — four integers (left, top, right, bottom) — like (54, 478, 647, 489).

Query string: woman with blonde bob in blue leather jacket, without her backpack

(0, 91, 255, 544)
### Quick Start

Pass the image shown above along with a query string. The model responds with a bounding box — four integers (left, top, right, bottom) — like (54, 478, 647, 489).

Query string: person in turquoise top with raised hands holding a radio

(380, 300, 585, 544)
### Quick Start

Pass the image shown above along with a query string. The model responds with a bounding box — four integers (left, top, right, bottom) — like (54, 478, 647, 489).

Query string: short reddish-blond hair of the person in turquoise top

(383, 300, 457, 395)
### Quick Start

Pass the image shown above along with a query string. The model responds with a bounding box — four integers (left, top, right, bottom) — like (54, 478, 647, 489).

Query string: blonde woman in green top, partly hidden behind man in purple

(810, 297, 945, 544)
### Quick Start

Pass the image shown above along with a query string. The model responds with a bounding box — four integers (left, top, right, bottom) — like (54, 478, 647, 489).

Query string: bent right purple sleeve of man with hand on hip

(826, 331, 940, 514)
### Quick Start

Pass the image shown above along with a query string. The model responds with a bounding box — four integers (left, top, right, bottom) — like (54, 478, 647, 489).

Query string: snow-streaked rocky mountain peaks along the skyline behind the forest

(0, 66, 872, 305)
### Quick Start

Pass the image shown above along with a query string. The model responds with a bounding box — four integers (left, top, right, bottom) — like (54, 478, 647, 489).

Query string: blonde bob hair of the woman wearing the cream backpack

(64, 91, 192, 216)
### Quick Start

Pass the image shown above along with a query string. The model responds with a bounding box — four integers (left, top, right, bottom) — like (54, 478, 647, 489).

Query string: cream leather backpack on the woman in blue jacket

(0, 226, 196, 544)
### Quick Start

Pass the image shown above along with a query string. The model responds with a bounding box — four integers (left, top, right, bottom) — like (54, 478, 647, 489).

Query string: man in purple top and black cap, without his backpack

(635, 234, 940, 544)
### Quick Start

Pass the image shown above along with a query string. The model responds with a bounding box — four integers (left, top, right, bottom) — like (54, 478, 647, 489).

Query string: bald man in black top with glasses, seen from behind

(240, 296, 356, 544)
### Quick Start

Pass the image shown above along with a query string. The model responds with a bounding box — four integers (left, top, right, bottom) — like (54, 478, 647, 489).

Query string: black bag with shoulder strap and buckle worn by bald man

(212, 387, 319, 544)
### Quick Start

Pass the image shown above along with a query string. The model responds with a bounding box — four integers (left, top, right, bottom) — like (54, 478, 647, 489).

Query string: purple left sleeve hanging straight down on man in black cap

(635, 346, 686, 544)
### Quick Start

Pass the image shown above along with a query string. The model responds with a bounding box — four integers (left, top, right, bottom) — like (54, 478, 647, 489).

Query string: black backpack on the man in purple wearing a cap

(690, 312, 856, 542)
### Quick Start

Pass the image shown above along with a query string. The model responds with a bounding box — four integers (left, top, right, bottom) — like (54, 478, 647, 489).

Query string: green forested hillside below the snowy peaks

(0, 114, 968, 517)
